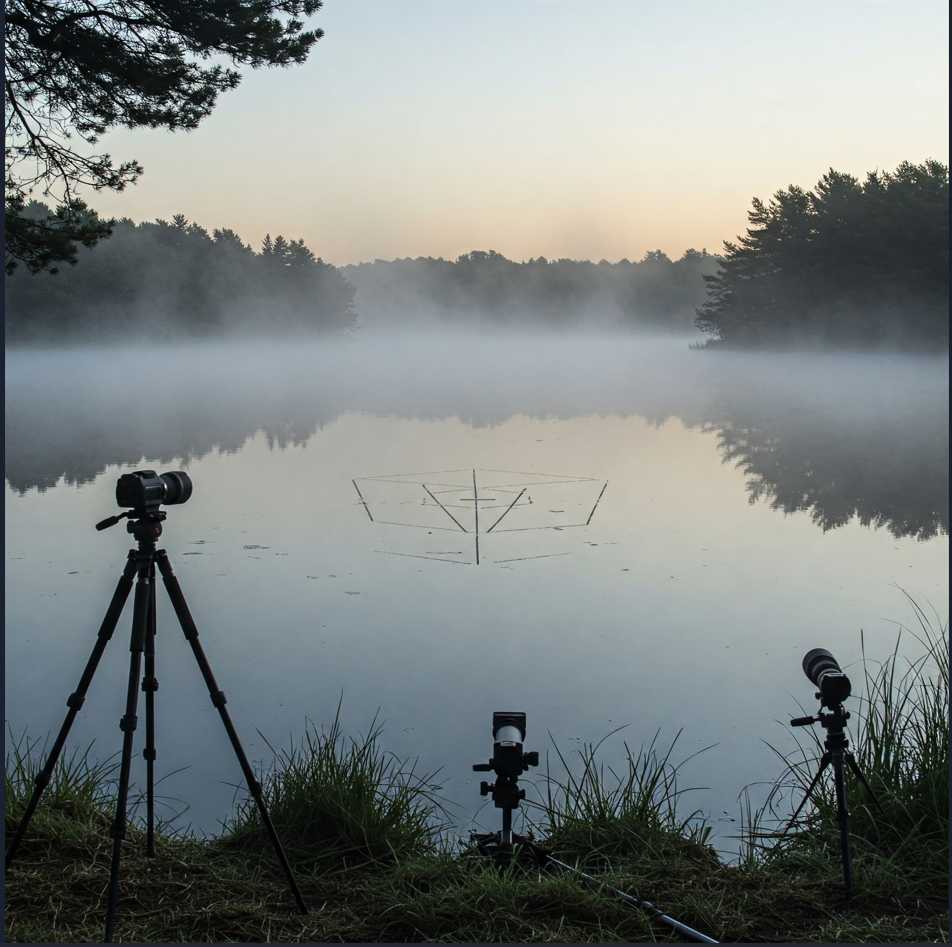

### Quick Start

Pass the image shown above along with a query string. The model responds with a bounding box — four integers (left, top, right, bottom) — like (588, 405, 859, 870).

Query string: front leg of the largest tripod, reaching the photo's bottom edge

(105, 553, 155, 944)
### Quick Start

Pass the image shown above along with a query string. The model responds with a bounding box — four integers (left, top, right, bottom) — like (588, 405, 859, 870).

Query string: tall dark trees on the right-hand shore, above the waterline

(696, 160, 949, 348)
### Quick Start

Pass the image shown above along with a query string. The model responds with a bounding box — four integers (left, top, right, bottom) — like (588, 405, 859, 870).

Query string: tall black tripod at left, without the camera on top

(5, 510, 308, 943)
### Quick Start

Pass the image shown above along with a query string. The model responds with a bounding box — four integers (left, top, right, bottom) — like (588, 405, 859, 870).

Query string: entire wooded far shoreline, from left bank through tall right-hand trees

(5, 159, 949, 352)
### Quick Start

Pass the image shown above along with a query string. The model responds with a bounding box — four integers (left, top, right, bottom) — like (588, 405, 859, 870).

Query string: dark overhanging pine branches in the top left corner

(4, 0, 323, 273)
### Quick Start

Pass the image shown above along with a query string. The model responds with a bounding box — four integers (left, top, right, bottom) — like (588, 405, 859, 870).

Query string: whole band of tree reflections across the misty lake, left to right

(5, 353, 949, 539)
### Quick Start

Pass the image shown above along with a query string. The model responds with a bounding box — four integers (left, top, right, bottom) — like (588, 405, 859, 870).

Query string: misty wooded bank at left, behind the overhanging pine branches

(5, 202, 356, 341)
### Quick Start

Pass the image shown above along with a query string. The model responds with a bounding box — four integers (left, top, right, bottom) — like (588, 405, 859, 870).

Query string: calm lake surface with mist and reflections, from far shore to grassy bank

(5, 333, 949, 850)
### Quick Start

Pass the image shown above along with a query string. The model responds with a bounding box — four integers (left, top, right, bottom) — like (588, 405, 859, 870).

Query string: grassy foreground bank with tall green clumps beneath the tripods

(5, 600, 949, 943)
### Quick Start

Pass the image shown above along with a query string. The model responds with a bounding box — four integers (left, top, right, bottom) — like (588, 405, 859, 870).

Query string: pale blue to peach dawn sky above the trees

(88, 0, 949, 266)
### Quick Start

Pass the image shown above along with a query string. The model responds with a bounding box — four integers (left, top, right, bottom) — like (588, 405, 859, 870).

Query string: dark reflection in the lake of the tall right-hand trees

(684, 357, 949, 540)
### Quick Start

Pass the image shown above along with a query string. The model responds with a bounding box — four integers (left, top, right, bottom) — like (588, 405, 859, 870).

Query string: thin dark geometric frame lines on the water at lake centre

(351, 469, 608, 565)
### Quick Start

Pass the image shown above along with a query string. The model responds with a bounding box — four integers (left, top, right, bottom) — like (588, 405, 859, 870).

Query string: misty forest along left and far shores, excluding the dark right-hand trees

(5, 202, 718, 341)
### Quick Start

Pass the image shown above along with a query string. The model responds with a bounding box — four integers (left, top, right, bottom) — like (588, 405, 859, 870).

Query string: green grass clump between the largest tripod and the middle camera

(224, 707, 444, 870)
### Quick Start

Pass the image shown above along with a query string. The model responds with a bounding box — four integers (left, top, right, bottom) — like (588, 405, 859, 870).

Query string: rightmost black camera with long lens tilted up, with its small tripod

(784, 648, 879, 901)
